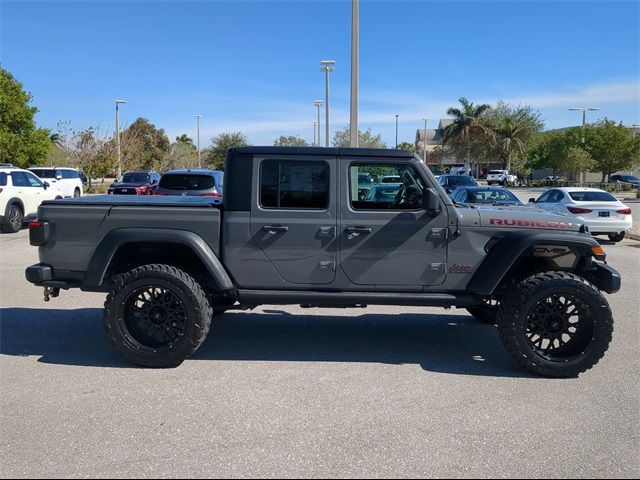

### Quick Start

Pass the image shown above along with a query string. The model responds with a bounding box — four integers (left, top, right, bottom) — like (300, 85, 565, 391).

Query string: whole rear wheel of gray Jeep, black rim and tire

(103, 265, 212, 368)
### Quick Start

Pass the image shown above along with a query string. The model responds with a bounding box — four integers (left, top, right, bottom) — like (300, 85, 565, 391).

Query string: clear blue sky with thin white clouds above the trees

(0, 0, 640, 148)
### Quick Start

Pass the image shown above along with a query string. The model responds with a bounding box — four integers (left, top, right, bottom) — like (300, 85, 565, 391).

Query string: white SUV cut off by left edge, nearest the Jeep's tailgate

(0, 164, 62, 233)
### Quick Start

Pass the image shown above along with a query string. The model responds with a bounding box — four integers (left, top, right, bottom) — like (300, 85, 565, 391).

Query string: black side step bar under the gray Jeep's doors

(238, 290, 480, 307)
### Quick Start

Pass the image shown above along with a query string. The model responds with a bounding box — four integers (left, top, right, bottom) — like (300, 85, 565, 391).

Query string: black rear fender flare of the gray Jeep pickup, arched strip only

(82, 228, 234, 291)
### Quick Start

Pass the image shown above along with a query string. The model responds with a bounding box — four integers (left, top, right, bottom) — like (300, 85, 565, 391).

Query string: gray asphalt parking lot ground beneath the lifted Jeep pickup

(0, 231, 640, 478)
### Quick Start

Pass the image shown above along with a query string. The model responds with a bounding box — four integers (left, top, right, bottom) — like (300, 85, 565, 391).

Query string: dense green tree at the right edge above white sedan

(584, 118, 640, 183)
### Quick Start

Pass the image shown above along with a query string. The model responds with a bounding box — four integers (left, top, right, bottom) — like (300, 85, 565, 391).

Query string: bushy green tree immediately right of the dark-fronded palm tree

(484, 102, 543, 171)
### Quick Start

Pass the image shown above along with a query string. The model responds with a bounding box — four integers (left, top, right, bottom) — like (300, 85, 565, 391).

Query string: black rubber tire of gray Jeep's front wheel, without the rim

(497, 272, 613, 378)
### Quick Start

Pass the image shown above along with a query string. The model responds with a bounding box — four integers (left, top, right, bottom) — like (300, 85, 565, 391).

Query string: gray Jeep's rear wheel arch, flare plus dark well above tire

(82, 228, 235, 292)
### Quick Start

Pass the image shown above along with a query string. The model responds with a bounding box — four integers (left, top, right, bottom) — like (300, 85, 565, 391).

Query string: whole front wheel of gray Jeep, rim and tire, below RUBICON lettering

(497, 272, 613, 378)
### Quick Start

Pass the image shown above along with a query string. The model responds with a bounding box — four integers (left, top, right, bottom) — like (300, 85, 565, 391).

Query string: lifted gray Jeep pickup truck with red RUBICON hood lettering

(26, 147, 621, 377)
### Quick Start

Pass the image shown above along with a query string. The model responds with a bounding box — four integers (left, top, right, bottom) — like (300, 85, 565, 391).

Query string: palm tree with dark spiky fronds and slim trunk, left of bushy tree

(443, 97, 493, 172)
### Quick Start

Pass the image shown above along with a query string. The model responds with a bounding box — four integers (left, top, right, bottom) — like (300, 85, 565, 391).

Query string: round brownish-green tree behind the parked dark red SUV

(121, 118, 171, 170)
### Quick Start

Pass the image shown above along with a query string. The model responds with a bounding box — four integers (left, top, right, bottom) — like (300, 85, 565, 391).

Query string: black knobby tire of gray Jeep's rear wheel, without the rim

(103, 264, 213, 368)
